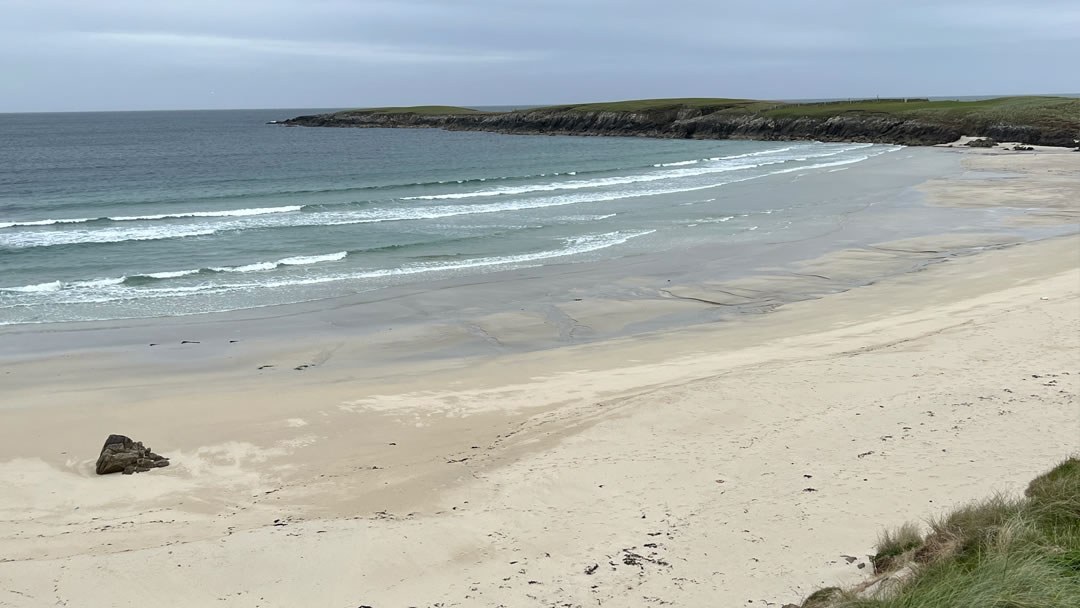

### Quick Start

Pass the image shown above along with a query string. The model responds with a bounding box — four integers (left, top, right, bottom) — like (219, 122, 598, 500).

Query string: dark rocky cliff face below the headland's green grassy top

(281, 108, 1076, 146)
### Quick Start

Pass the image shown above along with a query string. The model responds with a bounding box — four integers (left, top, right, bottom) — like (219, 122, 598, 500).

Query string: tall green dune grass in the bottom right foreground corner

(804, 458, 1080, 608)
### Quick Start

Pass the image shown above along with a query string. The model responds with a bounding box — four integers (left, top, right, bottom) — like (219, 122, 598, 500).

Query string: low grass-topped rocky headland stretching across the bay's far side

(276, 96, 1080, 147)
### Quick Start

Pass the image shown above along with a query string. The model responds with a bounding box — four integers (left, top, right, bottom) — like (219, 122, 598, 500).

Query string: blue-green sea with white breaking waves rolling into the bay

(0, 109, 900, 324)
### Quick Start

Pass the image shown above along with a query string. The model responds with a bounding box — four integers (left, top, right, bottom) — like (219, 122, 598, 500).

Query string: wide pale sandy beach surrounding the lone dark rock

(0, 149, 1080, 608)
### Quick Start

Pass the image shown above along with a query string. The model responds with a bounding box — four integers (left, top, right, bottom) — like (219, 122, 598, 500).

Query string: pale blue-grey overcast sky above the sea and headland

(0, 0, 1080, 112)
